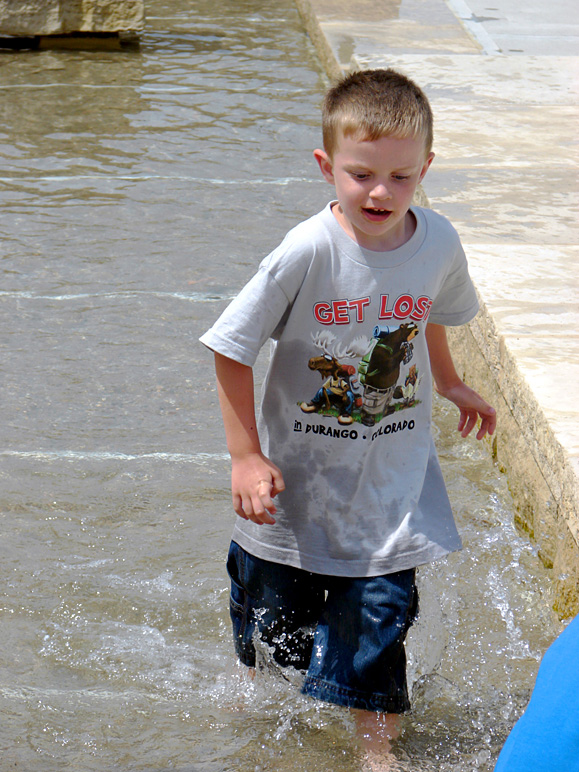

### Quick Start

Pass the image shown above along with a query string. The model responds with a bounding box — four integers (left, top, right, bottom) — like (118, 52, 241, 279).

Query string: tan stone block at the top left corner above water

(0, 0, 145, 37)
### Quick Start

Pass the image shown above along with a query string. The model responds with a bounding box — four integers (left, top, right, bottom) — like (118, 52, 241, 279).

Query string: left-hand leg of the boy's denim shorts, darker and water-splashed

(227, 542, 324, 670)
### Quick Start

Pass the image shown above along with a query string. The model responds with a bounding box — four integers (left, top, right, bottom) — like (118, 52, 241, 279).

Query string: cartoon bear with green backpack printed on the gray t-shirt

(358, 323, 419, 426)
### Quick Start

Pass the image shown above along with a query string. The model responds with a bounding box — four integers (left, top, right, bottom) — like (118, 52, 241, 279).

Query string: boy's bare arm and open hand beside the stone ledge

(426, 324, 497, 440)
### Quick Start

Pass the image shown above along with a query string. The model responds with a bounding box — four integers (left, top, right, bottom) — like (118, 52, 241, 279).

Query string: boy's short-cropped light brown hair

(322, 69, 433, 158)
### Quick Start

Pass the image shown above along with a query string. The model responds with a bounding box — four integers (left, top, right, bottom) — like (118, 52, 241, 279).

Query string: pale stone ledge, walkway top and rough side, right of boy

(295, 0, 579, 618)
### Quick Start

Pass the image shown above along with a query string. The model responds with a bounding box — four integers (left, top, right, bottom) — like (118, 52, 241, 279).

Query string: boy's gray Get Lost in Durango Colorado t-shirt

(201, 202, 478, 576)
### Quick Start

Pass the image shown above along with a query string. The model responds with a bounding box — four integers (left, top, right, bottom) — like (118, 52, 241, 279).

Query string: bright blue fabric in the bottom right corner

(495, 617, 579, 772)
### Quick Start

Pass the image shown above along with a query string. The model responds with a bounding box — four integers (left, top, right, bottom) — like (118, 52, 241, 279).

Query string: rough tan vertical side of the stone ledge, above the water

(448, 301, 579, 618)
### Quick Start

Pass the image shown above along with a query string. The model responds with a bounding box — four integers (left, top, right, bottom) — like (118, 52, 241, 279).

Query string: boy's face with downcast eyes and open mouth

(314, 135, 434, 252)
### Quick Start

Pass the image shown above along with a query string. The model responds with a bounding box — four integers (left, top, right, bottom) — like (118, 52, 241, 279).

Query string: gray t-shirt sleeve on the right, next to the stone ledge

(428, 232, 479, 327)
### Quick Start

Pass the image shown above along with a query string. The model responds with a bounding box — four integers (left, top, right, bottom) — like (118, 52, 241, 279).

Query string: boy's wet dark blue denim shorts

(227, 542, 418, 713)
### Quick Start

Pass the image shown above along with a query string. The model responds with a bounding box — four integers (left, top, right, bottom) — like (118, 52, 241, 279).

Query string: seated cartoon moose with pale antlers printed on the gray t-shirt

(300, 331, 361, 425)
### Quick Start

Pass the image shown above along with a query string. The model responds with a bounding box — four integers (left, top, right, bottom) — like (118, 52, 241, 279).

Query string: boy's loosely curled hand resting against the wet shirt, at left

(231, 453, 285, 525)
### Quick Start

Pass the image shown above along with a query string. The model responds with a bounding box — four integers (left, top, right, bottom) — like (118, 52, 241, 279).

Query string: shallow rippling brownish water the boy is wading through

(0, 0, 559, 772)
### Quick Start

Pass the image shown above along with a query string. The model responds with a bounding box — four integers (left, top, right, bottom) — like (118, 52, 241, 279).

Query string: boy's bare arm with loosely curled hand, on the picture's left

(215, 353, 285, 525)
